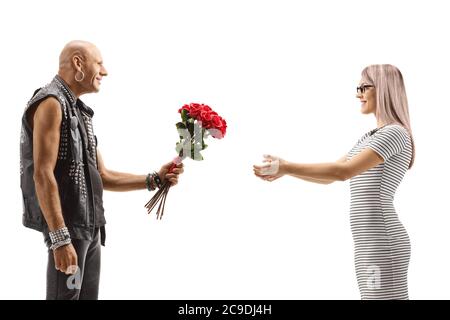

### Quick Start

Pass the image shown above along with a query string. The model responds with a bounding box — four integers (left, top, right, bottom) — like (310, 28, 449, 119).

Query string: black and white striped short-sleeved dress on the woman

(347, 124, 412, 299)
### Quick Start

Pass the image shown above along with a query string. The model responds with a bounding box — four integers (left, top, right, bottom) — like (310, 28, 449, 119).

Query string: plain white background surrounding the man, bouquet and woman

(0, 0, 450, 299)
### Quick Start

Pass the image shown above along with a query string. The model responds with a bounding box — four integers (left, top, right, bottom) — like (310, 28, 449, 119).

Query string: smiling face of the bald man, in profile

(83, 47, 108, 92)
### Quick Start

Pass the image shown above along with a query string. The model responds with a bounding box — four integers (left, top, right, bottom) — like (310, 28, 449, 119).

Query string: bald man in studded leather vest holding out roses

(20, 41, 183, 299)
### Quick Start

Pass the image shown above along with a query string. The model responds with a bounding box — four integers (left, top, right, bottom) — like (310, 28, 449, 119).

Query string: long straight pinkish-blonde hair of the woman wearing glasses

(361, 64, 415, 169)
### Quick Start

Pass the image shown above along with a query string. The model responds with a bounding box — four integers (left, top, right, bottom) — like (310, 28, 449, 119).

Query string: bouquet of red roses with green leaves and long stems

(145, 103, 227, 219)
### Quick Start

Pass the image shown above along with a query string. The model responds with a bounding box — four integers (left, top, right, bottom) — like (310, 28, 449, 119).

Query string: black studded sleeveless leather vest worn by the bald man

(20, 75, 106, 244)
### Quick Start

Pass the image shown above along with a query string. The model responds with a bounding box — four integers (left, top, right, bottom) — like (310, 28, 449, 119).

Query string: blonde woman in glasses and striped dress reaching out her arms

(254, 64, 415, 299)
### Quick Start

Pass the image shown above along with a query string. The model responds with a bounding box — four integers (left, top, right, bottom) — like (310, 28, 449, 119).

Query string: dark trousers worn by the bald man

(47, 228, 101, 300)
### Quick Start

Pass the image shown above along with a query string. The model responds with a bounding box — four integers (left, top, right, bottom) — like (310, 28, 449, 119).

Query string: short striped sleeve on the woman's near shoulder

(367, 125, 409, 161)
